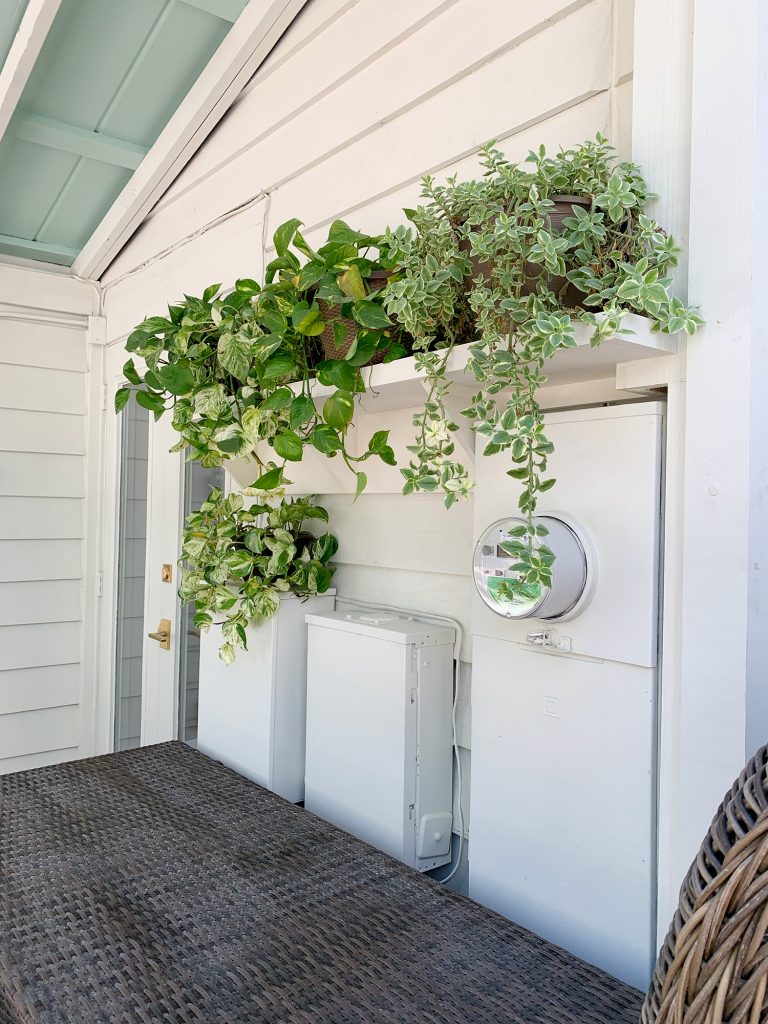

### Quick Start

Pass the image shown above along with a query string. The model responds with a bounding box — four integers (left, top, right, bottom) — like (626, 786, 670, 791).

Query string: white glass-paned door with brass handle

(98, 345, 189, 750)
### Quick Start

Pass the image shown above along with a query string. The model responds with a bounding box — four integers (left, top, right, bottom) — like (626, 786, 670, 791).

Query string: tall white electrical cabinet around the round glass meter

(469, 402, 664, 988)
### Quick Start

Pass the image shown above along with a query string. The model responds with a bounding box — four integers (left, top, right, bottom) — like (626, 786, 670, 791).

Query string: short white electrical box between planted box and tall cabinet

(304, 611, 456, 871)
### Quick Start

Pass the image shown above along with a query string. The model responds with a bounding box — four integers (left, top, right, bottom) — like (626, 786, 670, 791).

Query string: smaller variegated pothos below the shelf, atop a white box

(179, 489, 338, 664)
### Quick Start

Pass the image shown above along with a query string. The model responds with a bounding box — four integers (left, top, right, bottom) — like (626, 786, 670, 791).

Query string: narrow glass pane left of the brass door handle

(115, 401, 150, 751)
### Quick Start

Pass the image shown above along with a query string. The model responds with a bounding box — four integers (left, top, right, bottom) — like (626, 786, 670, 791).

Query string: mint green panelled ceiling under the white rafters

(0, 0, 248, 266)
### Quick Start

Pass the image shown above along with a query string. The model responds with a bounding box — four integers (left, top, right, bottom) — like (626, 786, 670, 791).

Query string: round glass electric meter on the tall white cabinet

(473, 515, 595, 621)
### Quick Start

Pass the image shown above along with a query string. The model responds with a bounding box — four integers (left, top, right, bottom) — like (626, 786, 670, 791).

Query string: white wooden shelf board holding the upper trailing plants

(305, 313, 677, 413)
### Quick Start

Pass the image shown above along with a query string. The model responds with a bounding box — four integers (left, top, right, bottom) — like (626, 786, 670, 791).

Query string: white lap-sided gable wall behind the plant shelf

(104, 0, 633, 835)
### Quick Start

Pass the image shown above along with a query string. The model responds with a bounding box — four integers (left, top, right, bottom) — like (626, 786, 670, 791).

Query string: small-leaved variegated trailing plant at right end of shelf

(385, 135, 702, 593)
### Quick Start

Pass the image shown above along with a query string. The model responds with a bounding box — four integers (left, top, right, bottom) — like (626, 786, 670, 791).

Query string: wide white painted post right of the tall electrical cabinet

(634, 0, 768, 938)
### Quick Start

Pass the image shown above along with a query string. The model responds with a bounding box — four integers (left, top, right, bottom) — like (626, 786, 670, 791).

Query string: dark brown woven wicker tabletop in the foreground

(0, 743, 642, 1024)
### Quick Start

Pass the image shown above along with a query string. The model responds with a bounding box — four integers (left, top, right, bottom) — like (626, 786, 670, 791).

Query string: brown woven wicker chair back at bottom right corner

(642, 746, 768, 1024)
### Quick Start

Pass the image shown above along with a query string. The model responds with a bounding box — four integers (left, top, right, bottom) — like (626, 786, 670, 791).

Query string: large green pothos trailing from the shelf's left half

(115, 221, 401, 494)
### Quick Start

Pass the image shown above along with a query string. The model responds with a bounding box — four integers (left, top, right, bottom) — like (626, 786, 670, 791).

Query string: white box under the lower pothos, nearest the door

(198, 591, 336, 803)
